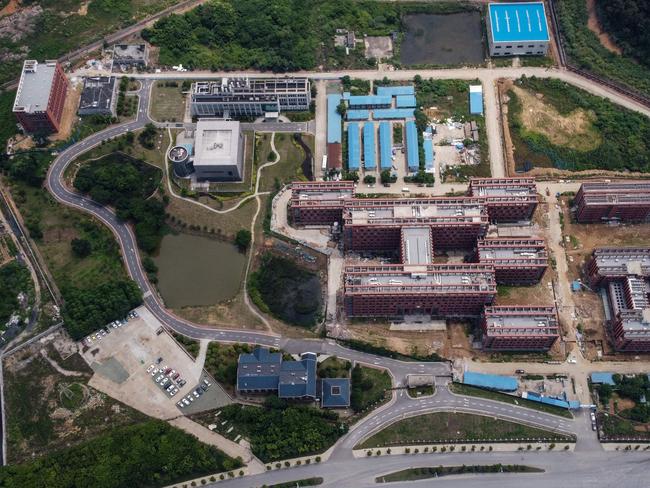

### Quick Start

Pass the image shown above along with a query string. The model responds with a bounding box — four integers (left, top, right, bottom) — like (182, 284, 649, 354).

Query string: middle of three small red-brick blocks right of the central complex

(476, 239, 548, 285)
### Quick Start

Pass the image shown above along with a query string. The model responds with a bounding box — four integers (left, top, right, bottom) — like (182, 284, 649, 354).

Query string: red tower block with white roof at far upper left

(13, 60, 68, 133)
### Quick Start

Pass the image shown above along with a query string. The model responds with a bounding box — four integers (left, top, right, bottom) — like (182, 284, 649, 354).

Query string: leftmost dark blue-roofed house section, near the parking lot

(237, 347, 282, 393)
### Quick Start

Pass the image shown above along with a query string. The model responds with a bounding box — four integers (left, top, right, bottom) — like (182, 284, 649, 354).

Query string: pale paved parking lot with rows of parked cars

(82, 307, 230, 419)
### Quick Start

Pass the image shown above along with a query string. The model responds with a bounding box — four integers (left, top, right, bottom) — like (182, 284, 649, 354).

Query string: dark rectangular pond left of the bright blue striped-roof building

(400, 11, 485, 66)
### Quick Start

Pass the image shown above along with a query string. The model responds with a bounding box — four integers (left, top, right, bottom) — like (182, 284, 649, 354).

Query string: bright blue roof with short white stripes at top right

(489, 2, 549, 42)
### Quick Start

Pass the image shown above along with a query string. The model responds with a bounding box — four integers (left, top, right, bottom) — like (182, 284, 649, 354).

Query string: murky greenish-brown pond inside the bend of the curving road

(154, 234, 246, 308)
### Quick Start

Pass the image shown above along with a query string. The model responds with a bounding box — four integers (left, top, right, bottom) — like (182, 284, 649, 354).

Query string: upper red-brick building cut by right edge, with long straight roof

(574, 181, 650, 223)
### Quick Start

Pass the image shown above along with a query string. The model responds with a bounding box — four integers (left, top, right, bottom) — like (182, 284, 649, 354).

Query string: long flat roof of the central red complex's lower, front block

(345, 264, 496, 293)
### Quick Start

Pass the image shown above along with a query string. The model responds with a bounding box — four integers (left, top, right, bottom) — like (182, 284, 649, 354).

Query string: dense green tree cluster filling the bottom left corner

(0, 420, 241, 488)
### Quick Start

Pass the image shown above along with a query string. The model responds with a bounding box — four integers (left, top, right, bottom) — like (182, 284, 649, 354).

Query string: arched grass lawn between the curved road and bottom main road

(357, 412, 572, 449)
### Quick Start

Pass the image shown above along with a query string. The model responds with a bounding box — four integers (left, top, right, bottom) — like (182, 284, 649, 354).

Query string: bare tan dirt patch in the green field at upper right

(512, 86, 602, 151)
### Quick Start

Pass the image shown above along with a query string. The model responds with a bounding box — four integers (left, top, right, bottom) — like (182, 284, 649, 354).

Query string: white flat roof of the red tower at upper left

(13, 60, 56, 113)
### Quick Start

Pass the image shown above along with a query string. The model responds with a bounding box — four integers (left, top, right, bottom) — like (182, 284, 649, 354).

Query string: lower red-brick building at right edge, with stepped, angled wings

(587, 248, 650, 352)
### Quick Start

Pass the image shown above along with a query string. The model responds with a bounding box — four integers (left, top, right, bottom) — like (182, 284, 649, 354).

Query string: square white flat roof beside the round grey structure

(194, 119, 239, 166)
